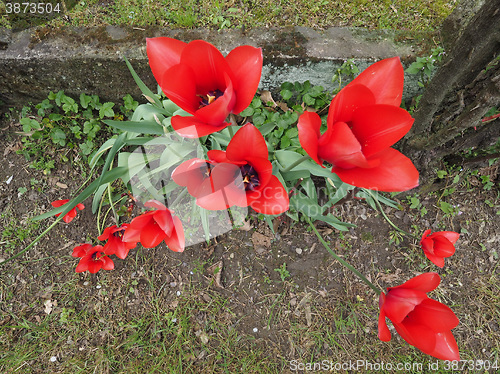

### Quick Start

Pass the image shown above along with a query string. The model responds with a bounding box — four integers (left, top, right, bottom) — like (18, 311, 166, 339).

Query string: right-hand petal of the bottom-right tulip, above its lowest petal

(408, 299, 459, 332)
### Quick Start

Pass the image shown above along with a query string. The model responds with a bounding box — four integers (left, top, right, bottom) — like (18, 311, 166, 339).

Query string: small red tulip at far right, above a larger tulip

(420, 230, 460, 268)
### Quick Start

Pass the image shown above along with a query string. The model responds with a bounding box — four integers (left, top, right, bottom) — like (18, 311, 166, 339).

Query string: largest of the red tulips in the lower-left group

(122, 200, 185, 252)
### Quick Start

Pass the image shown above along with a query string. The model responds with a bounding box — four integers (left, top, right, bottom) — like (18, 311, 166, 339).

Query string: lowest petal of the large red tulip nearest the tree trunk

(332, 148, 418, 192)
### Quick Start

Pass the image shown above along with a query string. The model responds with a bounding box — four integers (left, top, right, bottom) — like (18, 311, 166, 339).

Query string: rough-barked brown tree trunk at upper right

(402, 0, 500, 184)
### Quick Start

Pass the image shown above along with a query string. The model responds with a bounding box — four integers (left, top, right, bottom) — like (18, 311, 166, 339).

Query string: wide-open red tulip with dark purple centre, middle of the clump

(172, 124, 289, 214)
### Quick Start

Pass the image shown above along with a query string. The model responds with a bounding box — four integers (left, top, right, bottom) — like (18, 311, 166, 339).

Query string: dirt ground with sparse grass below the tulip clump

(0, 122, 500, 373)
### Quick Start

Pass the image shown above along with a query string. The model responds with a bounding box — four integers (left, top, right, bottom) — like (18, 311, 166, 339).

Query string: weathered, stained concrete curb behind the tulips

(0, 26, 430, 105)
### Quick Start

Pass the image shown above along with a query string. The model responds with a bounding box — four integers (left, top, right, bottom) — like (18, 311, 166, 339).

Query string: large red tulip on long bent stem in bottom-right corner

(378, 273, 460, 360)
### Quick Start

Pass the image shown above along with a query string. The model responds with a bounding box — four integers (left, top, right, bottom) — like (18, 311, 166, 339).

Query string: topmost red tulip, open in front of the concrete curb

(146, 37, 262, 138)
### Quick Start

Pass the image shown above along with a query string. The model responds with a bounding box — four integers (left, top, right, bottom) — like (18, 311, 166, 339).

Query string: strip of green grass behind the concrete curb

(0, 0, 456, 32)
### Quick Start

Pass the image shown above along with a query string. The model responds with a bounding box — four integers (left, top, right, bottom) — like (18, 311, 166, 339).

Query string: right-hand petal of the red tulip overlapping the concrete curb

(226, 45, 262, 114)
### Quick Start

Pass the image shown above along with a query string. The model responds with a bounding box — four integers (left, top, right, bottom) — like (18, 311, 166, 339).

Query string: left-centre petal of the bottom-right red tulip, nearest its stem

(384, 288, 427, 323)
